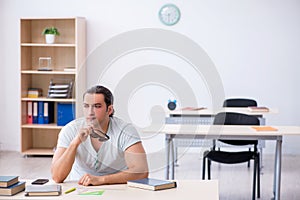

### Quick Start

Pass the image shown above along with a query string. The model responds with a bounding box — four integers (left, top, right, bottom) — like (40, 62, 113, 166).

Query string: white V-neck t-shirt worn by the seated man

(57, 117, 141, 180)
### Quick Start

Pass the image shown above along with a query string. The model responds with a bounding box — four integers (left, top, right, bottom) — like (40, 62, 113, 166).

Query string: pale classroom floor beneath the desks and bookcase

(0, 151, 300, 200)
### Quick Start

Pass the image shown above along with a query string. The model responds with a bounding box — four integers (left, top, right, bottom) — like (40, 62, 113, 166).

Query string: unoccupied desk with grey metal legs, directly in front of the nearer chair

(143, 124, 300, 200)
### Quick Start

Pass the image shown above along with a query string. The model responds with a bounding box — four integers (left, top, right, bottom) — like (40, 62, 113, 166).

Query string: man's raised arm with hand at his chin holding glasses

(51, 127, 90, 183)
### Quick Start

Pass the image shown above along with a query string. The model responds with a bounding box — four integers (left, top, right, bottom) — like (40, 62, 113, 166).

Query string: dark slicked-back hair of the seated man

(83, 85, 115, 117)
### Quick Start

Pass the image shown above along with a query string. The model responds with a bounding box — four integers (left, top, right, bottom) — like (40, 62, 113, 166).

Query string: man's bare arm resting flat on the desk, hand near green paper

(78, 142, 148, 186)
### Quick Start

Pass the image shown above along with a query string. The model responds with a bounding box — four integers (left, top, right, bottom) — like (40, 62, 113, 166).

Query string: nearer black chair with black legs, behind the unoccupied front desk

(202, 112, 260, 200)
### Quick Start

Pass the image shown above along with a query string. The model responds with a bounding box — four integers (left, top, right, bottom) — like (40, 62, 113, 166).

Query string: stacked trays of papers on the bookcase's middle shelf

(48, 79, 73, 98)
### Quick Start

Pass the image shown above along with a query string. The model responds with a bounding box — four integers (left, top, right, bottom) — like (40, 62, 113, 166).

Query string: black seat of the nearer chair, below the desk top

(204, 151, 256, 164)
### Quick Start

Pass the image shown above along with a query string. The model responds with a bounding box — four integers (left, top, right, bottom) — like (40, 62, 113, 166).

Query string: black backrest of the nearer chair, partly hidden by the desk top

(213, 112, 260, 145)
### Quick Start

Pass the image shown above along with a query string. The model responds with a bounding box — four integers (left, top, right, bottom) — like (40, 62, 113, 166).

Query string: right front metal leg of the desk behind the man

(274, 138, 282, 200)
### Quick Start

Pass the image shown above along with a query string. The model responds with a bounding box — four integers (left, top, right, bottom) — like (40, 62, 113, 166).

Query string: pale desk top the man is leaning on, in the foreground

(0, 180, 219, 200)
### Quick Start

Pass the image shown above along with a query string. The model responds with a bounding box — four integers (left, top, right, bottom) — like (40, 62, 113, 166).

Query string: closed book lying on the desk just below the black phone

(25, 184, 61, 196)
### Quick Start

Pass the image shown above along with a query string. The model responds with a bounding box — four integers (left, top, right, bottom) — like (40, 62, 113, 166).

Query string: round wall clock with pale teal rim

(159, 4, 180, 26)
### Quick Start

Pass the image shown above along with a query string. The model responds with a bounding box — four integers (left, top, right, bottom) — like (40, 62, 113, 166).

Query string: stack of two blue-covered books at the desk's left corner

(0, 176, 25, 196)
